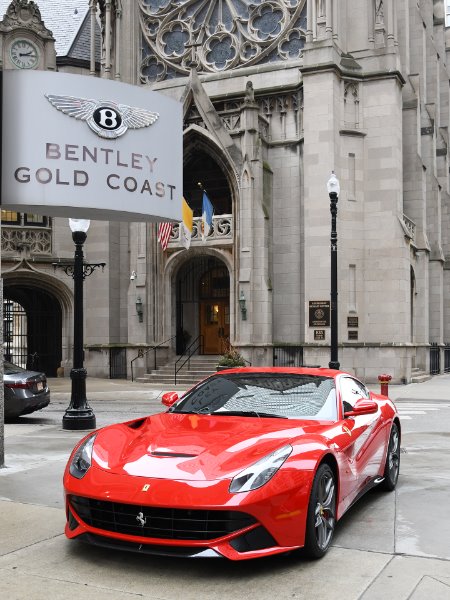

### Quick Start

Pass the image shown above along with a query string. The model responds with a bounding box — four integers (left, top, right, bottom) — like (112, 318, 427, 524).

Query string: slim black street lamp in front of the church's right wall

(327, 171, 340, 369)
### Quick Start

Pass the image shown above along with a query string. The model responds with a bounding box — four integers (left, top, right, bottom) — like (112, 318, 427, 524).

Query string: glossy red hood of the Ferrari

(92, 413, 329, 481)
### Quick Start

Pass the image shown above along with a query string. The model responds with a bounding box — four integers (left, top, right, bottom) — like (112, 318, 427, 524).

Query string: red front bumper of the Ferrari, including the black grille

(64, 469, 310, 560)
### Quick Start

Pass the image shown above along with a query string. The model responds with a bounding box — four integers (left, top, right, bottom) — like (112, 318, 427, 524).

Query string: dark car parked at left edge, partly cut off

(3, 361, 50, 420)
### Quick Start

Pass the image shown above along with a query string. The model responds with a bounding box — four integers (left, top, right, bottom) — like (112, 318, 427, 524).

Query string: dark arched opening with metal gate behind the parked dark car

(3, 281, 62, 377)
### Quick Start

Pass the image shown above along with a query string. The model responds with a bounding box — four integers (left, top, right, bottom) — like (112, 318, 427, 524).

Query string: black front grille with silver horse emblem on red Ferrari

(70, 496, 256, 541)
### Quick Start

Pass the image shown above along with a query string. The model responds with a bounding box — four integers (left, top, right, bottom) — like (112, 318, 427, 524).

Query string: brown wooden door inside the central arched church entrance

(200, 299, 230, 354)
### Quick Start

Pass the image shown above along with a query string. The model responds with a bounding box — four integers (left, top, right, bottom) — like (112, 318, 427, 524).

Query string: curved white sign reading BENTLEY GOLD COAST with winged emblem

(1, 70, 183, 221)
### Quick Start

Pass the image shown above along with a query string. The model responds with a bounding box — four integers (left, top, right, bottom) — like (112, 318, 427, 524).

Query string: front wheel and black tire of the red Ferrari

(304, 464, 336, 558)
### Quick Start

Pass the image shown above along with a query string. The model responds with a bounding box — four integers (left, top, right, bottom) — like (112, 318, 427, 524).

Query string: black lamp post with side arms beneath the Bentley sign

(53, 219, 105, 430)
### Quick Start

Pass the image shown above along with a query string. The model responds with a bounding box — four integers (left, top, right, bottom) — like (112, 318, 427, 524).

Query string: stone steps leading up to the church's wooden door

(137, 354, 219, 391)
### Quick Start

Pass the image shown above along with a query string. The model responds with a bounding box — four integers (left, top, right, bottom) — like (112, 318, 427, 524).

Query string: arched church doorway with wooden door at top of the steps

(176, 256, 230, 354)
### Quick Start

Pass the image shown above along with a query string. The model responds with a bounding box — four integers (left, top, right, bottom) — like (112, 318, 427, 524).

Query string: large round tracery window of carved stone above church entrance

(138, 0, 306, 83)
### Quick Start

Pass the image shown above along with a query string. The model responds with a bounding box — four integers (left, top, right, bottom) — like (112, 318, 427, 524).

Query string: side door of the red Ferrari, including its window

(335, 375, 384, 504)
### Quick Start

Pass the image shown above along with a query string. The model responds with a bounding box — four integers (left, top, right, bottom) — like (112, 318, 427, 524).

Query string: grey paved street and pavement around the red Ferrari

(0, 375, 450, 600)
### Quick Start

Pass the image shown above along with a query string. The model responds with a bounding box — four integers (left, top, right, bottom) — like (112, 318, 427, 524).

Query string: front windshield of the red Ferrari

(171, 373, 337, 421)
